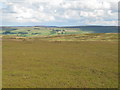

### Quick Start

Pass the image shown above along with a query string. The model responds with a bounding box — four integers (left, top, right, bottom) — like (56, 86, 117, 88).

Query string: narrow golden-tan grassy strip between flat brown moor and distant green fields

(3, 33, 119, 41)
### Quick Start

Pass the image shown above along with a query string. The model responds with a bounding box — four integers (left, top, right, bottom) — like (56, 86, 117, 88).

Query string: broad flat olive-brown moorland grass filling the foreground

(3, 39, 118, 88)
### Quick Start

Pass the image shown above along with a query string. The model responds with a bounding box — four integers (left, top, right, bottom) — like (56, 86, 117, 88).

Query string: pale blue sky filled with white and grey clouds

(0, 0, 119, 26)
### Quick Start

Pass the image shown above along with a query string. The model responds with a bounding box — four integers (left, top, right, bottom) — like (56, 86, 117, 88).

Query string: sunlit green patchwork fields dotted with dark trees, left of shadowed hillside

(0, 27, 92, 37)
